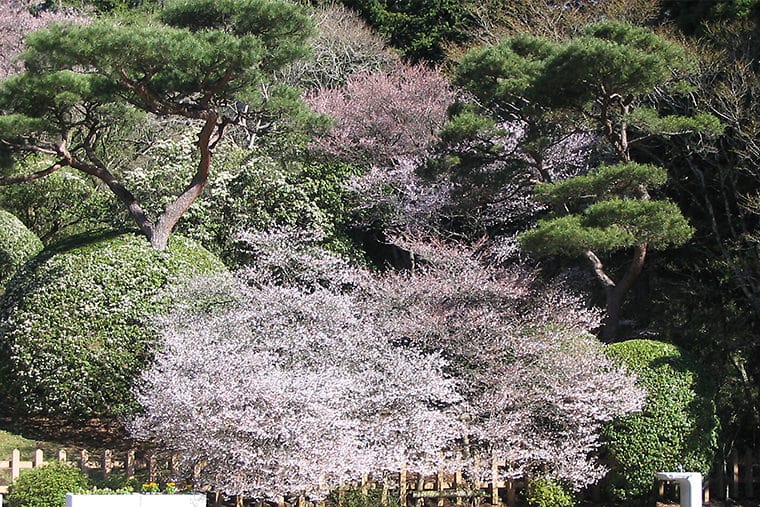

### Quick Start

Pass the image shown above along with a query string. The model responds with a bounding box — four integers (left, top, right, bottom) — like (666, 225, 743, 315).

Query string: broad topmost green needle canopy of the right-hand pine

(455, 22, 689, 111)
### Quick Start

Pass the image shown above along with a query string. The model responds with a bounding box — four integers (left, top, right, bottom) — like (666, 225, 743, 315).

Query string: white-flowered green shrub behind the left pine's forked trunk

(119, 132, 355, 264)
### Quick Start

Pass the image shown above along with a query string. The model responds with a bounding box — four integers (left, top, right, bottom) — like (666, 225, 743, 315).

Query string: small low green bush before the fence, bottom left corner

(8, 462, 87, 507)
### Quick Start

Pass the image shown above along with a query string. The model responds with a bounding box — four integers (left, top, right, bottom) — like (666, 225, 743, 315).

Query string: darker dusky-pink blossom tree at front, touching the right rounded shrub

(368, 242, 645, 489)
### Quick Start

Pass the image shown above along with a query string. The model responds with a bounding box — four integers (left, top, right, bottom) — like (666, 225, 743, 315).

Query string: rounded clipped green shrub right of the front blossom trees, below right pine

(602, 340, 718, 500)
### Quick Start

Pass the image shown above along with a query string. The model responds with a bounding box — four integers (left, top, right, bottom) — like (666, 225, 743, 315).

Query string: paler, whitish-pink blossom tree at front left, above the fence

(131, 231, 462, 498)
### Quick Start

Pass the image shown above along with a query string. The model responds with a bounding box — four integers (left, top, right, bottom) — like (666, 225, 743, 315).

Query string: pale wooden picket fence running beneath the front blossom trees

(0, 449, 523, 507)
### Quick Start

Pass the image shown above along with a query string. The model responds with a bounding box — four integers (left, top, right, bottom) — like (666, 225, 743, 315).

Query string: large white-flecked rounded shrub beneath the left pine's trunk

(0, 234, 224, 418)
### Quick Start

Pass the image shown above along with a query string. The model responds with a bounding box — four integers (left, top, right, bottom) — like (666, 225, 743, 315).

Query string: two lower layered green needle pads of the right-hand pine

(519, 162, 694, 256)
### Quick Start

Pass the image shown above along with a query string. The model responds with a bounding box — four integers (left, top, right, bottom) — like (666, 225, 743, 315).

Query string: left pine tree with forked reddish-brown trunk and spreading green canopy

(0, 0, 318, 249)
